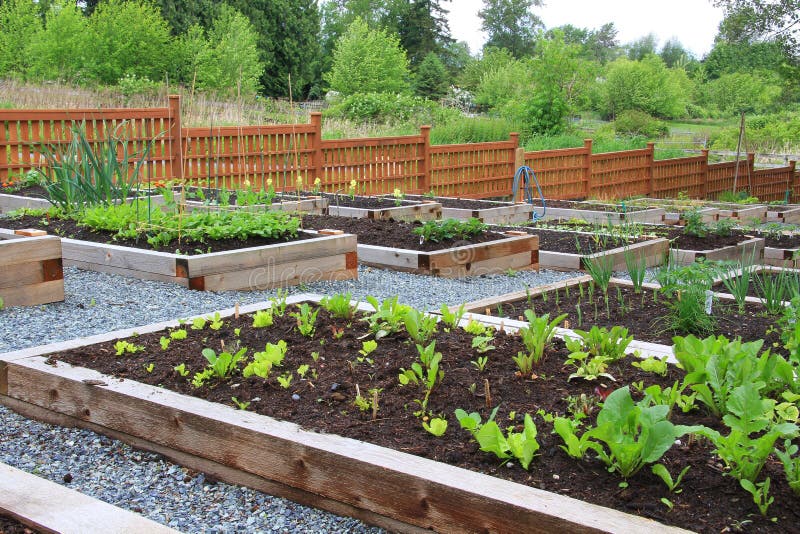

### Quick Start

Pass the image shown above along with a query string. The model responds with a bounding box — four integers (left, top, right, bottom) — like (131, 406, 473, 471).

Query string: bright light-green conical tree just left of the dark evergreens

(195, 4, 263, 95)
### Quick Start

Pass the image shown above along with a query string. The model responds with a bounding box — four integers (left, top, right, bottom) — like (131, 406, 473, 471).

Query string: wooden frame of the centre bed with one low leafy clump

(358, 231, 539, 278)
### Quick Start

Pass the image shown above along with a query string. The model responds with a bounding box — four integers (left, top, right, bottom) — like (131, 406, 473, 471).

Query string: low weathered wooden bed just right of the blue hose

(543, 200, 666, 224)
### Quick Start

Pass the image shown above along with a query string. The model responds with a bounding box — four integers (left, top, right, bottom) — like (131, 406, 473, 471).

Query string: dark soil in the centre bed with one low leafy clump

(303, 215, 508, 252)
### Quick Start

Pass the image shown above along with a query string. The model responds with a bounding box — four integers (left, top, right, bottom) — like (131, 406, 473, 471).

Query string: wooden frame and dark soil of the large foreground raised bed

(0, 300, 796, 532)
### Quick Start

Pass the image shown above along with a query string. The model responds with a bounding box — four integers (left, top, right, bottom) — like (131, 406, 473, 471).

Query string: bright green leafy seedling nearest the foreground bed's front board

(455, 408, 539, 469)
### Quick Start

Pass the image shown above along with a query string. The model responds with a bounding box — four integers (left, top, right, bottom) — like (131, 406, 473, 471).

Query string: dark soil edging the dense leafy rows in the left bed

(0, 215, 316, 256)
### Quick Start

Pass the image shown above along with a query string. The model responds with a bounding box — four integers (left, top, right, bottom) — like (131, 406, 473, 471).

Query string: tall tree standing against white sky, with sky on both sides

(478, 0, 544, 58)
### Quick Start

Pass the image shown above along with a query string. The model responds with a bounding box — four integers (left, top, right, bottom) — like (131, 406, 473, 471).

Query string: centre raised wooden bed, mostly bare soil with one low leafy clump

(303, 215, 539, 278)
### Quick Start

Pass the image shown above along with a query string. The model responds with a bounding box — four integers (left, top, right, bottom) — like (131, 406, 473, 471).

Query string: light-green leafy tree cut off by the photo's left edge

(0, 0, 42, 77)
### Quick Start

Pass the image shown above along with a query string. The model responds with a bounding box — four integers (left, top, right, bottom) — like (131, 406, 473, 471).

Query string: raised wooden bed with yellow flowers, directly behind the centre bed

(322, 193, 442, 221)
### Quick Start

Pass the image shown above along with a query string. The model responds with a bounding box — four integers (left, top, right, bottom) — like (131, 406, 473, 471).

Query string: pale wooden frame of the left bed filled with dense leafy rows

(0, 228, 358, 291)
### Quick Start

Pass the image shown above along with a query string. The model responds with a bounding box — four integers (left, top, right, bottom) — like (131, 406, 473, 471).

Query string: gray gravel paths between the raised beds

(0, 267, 576, 532)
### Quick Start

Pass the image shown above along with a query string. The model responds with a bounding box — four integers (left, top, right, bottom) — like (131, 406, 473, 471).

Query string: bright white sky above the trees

(442, 0, 722, 59)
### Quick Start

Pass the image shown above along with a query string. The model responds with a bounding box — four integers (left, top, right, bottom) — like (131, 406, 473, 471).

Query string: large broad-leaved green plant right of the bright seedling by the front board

(553, 386, 700, 478)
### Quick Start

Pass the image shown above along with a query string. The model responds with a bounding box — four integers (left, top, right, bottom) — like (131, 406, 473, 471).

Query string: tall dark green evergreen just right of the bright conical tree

(226, 0, 320, 97)
